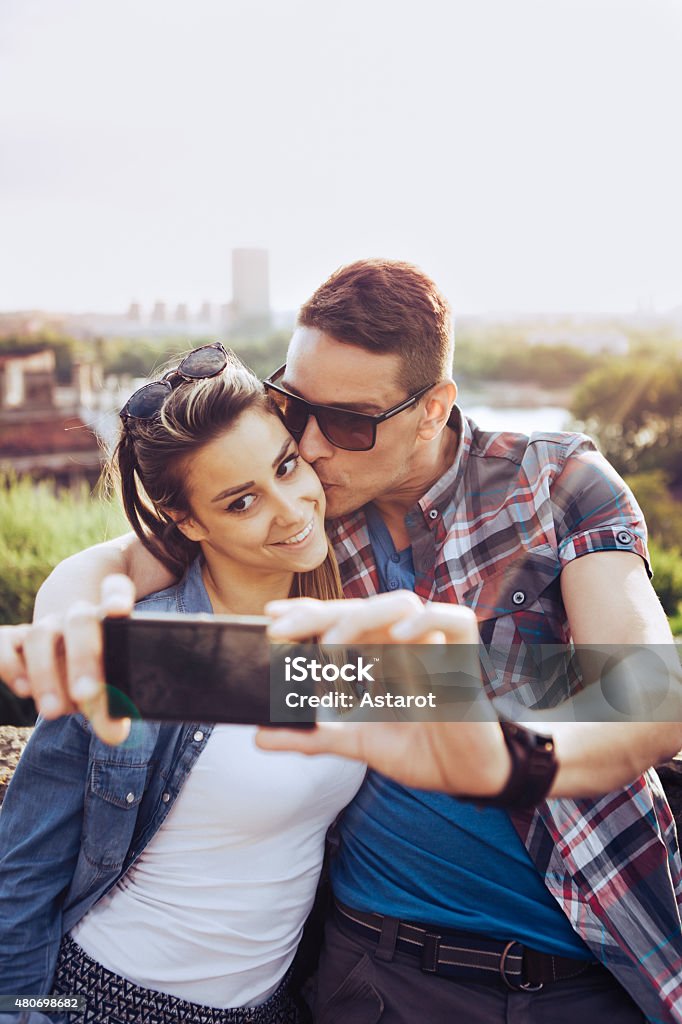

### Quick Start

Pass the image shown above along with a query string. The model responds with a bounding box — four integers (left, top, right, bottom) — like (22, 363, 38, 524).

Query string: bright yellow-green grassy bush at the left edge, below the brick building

(0, 474, 127, 623)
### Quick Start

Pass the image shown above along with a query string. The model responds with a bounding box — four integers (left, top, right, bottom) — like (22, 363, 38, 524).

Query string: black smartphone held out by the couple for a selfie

(103, 612, 314, 728)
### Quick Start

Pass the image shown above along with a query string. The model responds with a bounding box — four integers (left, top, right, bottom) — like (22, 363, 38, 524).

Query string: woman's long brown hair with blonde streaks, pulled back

(109, 352, 343, 600)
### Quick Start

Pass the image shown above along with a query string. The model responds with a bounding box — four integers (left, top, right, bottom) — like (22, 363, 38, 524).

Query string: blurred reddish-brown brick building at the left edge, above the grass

(0, 349, 102, 485)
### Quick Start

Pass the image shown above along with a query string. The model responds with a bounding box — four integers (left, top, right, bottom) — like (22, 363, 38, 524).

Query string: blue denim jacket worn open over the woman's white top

(0, 561, 212, 1024)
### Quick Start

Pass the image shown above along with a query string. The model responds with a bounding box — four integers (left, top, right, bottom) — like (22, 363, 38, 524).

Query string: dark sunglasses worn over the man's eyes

(263, 362, 434, 452)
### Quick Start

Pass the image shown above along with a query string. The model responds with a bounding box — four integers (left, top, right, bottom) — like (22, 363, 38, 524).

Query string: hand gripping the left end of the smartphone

(0, 575, 135, 743)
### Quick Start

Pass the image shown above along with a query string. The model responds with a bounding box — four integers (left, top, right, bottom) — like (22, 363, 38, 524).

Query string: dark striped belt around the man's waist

(336, 900, 601, 992)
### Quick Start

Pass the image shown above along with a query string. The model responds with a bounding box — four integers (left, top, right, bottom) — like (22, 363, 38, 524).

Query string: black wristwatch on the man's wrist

(464, 721, 559, 810)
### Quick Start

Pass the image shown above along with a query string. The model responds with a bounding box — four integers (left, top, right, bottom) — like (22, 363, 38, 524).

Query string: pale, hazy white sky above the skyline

(0, 0, 682, 312)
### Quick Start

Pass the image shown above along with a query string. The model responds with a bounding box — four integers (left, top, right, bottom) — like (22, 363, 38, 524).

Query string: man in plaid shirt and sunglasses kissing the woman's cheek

(1, 260, 682, 1024)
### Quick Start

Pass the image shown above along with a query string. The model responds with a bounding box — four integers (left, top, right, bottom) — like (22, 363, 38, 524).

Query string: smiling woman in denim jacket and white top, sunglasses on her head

(0, 345, 364, 1024)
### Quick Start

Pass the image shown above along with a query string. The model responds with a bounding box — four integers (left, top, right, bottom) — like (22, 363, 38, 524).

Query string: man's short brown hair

(298, 259, 454, 394)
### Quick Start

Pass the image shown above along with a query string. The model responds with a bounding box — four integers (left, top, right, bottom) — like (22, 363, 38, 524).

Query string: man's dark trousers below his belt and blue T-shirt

(314, 919, 646, 1024)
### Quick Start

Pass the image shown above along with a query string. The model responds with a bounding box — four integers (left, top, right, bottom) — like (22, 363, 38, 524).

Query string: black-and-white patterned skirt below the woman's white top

(52, 935, 303, 1024)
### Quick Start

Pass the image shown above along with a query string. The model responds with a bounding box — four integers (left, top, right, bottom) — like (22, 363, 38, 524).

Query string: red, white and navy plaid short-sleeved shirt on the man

(330, 409, 682, 1022)
